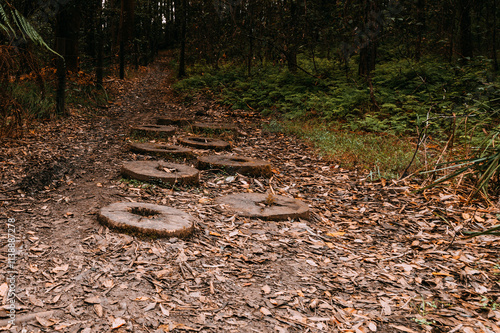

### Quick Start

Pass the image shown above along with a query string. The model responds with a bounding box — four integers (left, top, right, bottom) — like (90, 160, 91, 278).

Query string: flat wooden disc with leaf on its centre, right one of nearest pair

(216, 193, 309, 220)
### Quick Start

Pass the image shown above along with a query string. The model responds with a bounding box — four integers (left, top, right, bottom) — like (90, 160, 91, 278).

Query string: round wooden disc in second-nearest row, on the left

(121, 161, 200, 185)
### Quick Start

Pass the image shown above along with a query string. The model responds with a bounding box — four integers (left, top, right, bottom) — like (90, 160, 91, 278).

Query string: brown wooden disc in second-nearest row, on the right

(196, 155, 273, 177)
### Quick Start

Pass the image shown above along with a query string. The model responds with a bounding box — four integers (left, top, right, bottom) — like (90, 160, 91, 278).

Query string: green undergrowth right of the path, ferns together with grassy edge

(174, 57, 500, 177)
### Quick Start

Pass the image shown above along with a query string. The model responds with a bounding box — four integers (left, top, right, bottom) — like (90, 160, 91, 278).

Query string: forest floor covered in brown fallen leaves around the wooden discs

(0, 53, 500, 333)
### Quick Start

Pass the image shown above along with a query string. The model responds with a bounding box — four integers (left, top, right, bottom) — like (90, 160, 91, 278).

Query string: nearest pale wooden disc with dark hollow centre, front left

(97, 202, 197, 238)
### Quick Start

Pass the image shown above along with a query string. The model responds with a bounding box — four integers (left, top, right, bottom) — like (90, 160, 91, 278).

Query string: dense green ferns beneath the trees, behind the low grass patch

(174, 58, 500, 141)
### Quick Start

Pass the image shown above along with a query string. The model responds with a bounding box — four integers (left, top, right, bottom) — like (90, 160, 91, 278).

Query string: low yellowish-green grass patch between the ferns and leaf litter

(264, 120, 421, 180)
